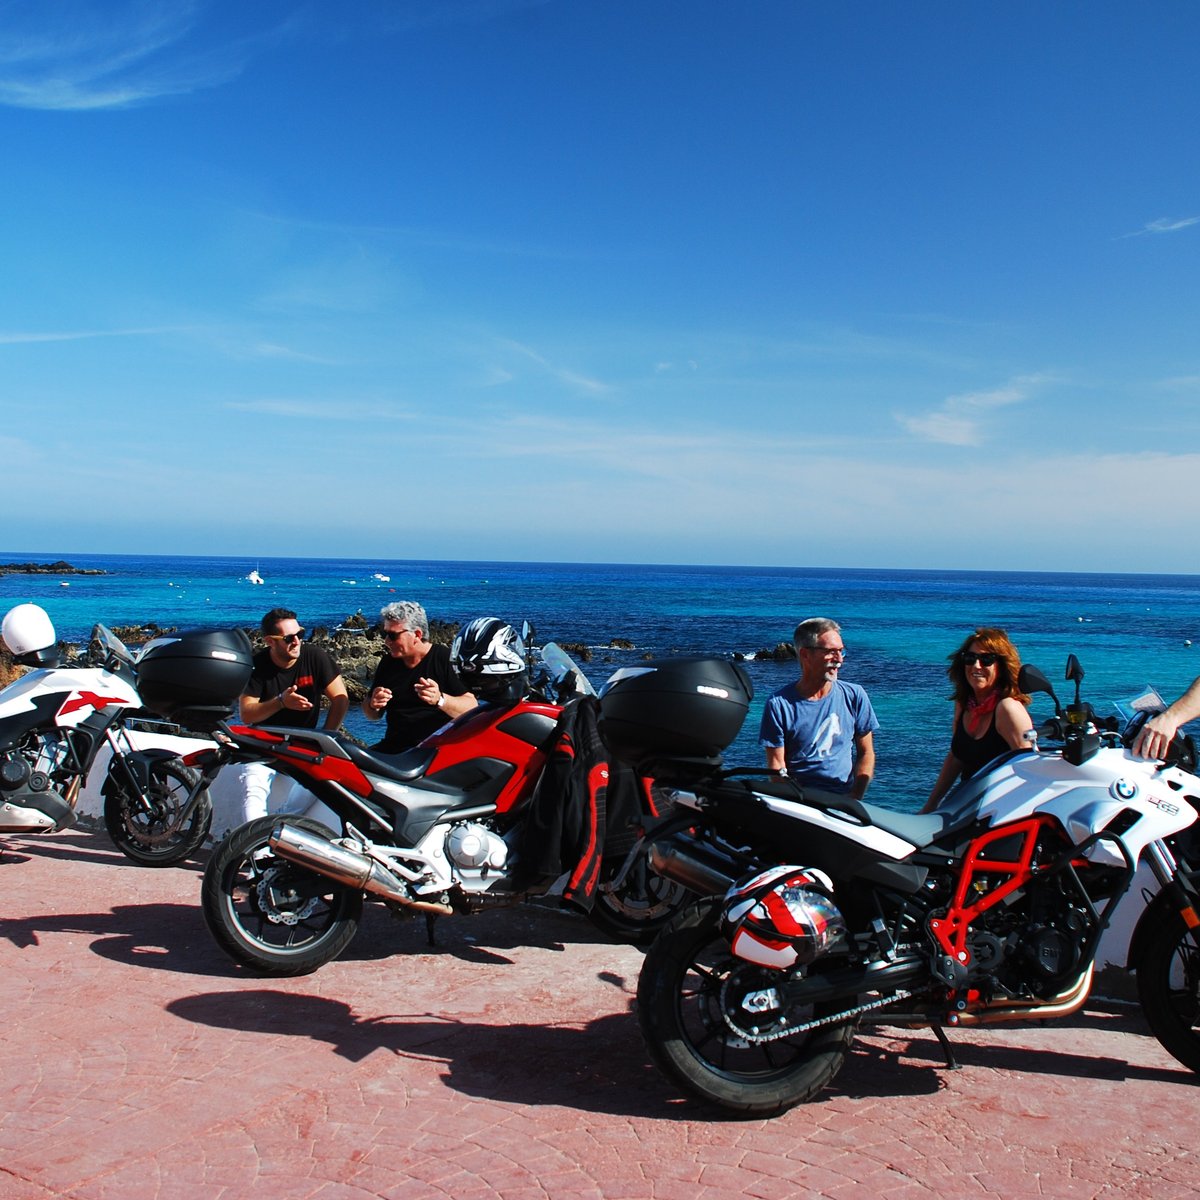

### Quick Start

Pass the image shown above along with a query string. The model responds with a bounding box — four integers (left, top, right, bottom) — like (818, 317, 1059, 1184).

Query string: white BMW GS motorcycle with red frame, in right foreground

(601, 655, 1200, 1116)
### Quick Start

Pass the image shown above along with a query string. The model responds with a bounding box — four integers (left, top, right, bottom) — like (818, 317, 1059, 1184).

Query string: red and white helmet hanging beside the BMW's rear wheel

(721, 866, 846, 971)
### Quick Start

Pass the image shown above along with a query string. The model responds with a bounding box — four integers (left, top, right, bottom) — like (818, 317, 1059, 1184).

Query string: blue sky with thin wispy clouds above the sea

(0, 0, 1200, 574)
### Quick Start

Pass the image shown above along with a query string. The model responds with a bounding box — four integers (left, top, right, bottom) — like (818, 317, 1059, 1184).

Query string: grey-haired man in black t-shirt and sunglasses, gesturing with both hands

(362, 600, 479, 754)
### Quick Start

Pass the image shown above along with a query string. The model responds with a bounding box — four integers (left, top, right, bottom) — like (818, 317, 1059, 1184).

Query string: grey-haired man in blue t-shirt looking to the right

(758, 617, 880, 799)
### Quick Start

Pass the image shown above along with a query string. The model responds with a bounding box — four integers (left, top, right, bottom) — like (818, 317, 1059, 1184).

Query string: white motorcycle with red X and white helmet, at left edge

(0, 604, 215, 866)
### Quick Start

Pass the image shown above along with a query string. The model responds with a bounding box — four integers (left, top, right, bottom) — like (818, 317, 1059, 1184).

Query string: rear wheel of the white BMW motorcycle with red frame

(637, 896, 858, 1117)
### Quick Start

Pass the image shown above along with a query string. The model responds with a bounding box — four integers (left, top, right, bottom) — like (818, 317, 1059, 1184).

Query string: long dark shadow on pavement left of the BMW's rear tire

(167, 989, 700, 1120)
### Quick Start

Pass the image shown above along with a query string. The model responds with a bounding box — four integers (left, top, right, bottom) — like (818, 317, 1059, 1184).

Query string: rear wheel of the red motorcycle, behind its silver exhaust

(200, 816, 362, 976)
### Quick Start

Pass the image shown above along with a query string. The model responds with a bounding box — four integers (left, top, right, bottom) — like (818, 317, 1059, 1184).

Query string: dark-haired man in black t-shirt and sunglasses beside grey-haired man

(234, 608, 350, 821)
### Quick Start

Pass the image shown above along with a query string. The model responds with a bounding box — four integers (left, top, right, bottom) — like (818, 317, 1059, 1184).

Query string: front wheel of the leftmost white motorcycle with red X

(104, 758, 212, 866)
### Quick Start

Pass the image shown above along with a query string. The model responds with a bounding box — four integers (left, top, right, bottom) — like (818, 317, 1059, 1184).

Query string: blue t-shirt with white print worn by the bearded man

(758, 679, 880, 792)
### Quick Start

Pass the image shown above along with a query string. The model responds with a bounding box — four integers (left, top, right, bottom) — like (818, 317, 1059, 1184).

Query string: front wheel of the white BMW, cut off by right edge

(1138, 913, 1200, 1073)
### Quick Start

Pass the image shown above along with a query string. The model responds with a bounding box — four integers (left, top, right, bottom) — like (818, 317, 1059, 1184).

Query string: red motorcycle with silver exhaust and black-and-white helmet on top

(200, 618, 686, 976)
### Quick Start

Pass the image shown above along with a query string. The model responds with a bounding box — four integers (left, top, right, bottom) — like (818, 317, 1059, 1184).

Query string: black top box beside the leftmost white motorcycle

(137, 629, 253, 716)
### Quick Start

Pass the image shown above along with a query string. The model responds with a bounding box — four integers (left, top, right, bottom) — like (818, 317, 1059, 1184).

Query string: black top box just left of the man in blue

(600, 658, 754, 768)
